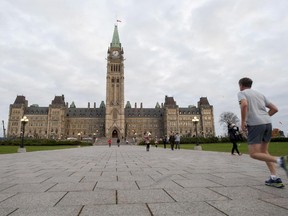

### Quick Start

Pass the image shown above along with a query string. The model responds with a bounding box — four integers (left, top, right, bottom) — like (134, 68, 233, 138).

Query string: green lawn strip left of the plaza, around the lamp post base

(0, 145, 81, 154)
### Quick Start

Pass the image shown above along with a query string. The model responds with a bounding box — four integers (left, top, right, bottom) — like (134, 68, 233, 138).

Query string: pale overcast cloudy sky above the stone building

(0, 0, 288, 137)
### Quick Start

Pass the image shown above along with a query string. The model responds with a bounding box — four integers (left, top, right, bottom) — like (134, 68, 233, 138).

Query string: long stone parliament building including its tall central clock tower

(7, 25, 215, 139)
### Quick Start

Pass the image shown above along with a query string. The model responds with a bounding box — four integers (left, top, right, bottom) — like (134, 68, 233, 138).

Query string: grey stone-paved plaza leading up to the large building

(0, 145, 288, 216)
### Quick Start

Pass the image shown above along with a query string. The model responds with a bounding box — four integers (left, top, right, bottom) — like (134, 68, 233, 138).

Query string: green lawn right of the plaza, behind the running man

(159, 142, 288, 156)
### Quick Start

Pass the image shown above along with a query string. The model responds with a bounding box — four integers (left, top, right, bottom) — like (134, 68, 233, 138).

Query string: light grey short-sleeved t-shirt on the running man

(238, 89, 271, 126)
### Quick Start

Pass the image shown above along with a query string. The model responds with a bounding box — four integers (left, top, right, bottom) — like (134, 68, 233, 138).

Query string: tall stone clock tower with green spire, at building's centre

(105, 25, 125, 139)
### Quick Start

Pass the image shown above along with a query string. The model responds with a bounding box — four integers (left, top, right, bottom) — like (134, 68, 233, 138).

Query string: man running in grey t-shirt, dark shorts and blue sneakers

(238, 77, 288, 188)
